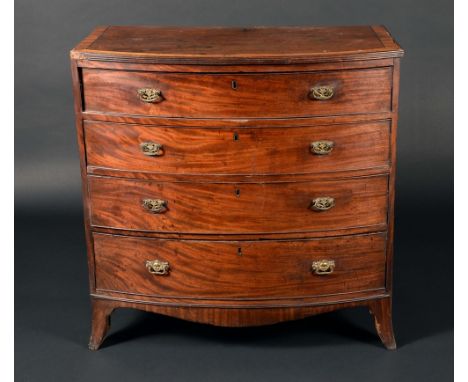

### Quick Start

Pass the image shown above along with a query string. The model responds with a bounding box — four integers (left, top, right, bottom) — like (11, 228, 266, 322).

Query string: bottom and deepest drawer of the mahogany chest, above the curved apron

(94, 233, 386, 299)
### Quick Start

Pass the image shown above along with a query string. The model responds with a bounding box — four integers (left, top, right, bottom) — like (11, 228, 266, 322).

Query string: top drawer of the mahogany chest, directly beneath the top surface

(83, 67, 392, 118)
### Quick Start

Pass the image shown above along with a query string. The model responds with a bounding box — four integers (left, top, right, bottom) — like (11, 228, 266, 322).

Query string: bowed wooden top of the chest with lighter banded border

(71, 26, 403, 64)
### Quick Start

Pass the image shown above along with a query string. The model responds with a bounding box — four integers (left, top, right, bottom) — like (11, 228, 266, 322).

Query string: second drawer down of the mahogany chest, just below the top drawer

(84, 121, 390, 174)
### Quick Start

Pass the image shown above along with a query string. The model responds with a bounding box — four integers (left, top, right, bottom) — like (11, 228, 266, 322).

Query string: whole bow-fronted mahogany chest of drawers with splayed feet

(71, 26, 403, 349)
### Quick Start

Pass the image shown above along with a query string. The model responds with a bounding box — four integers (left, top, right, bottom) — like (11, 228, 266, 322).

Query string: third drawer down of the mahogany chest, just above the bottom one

(88, 176, 388, 234)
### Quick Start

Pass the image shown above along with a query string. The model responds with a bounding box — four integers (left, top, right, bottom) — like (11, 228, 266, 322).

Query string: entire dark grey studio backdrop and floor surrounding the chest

(15, 0, 453, 382)
